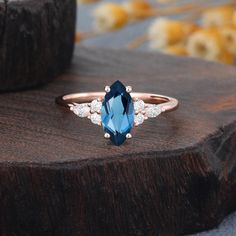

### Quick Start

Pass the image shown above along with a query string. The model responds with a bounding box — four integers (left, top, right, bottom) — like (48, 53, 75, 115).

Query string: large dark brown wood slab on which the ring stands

(0, 45, 236, 236)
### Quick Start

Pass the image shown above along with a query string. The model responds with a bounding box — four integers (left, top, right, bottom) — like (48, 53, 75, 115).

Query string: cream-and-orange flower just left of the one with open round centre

(148, 18, 196, 49)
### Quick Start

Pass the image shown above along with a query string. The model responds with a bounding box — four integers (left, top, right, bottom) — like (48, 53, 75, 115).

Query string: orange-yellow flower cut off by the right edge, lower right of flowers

(219, 26, 236, 55)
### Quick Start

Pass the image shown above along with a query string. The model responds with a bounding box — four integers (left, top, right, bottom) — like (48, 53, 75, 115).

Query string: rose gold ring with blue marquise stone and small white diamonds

(56, 81, 178, 146)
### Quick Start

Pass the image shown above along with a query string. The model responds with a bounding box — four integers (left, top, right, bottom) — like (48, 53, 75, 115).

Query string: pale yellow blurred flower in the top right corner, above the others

(202, 5, 234, 27)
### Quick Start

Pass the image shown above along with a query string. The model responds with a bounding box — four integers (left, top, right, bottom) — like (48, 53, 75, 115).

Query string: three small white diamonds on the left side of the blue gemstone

(70, 99, 102, 125)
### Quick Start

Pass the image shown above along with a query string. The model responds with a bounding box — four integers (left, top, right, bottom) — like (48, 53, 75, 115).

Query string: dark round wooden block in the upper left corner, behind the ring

(0, 0, 76, 91)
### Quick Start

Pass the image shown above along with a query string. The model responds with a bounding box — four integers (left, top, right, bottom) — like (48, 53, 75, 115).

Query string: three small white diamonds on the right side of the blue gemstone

(134, 99, 161, 126)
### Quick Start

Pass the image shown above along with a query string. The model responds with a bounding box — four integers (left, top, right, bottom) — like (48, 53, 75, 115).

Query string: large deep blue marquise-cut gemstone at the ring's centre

(101, 81, 134, 146)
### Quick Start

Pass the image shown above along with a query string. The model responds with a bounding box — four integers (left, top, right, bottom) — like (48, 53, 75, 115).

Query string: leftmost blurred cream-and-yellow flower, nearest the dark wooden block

(93, 3, 128, 32)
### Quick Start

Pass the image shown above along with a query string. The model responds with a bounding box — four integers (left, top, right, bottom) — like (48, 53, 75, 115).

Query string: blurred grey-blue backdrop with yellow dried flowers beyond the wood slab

(76, 0, 236, 64)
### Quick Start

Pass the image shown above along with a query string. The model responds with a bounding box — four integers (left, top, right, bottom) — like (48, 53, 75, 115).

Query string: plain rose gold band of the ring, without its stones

(56, 92, 178, 112)
